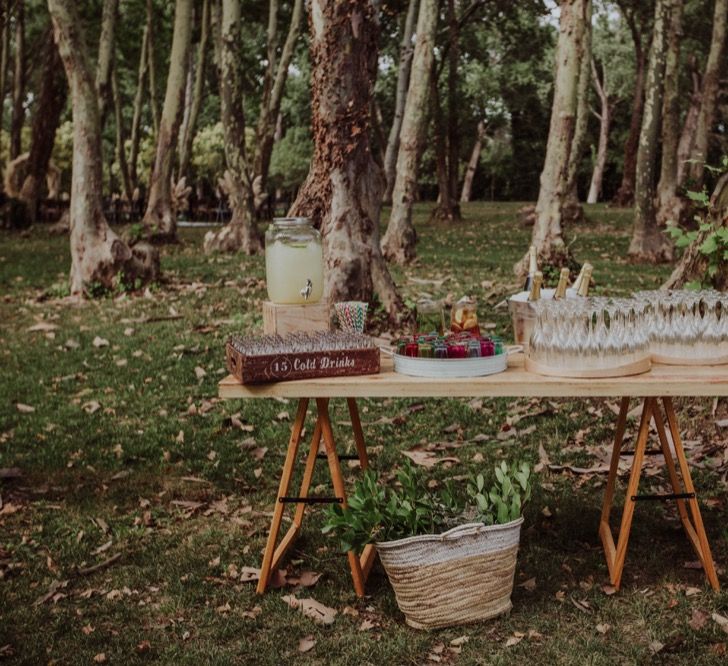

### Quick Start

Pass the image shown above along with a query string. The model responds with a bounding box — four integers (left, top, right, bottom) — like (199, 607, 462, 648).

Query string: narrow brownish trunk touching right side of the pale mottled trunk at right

(656, 0, 683, 227)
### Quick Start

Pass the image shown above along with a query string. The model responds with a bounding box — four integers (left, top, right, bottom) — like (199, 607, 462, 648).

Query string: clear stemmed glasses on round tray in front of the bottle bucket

(528, 297, 650, 370)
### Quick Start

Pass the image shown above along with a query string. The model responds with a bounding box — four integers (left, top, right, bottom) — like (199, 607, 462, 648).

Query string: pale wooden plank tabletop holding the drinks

(218, 354, 728, 399)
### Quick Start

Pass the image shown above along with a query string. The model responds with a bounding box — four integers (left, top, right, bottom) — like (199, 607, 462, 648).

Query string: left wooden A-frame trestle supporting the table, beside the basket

(256, 398, 376, 597)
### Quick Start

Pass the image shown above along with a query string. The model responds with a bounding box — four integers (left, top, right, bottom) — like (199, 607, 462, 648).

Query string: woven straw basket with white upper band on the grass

(377, 518, 523, 629)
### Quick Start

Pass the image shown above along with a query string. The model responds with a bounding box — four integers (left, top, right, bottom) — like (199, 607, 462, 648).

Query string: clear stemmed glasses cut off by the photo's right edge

(635, 290, 728, 363)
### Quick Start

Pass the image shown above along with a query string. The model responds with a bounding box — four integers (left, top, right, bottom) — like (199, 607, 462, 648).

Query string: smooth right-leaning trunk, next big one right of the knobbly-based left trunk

(143, 0, 192, 242)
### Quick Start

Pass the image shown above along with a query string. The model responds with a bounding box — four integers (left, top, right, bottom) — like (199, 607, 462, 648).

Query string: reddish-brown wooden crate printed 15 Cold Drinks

(225, 343, 379, 384)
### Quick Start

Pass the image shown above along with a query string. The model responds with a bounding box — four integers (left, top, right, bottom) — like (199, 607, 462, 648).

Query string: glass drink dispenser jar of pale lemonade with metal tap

(265, 217, 324, 304)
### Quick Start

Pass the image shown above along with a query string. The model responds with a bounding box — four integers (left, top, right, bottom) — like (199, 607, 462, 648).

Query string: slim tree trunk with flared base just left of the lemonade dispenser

(204, 0, 263, 254)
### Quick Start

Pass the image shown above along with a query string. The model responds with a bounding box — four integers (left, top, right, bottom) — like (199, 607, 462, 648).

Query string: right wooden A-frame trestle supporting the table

(599, 397, 720, 590)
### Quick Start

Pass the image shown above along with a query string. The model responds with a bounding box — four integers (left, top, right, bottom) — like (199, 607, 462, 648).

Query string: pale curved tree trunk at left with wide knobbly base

(48, 0, 159, 297)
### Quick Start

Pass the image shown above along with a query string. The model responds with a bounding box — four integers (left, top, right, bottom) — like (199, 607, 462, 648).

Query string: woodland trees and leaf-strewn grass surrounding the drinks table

(0, 0, 728, 665)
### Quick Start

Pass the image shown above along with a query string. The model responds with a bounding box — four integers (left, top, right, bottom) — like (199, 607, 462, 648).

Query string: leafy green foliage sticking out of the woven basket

(322, 461, 531, 551)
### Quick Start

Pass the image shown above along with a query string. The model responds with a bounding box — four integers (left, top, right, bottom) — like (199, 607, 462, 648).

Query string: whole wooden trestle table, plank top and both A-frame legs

(218, 354, 728, 596)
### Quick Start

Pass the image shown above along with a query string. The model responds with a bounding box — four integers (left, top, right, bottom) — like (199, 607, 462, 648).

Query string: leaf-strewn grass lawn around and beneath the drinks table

(0, 203, 728, 665)
